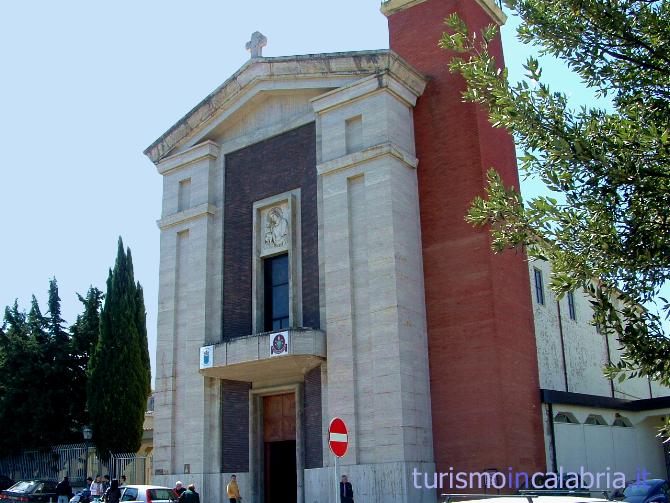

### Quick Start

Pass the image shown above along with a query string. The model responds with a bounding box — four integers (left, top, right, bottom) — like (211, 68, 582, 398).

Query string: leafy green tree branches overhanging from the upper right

(441, 0, 670, 396)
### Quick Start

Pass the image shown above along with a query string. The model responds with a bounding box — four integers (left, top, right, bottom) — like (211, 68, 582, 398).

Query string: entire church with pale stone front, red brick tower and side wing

(145, 0, 670, 503)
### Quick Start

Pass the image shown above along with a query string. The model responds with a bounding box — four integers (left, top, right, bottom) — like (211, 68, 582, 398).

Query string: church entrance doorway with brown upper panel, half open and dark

(263, 393, 298, 503)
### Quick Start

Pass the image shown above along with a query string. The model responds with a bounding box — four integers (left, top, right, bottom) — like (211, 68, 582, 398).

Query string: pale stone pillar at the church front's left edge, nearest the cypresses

(154, 142, 223, 498)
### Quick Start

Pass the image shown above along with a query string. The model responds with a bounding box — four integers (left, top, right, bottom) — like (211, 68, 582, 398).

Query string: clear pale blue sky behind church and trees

(0, 0, 636, 382)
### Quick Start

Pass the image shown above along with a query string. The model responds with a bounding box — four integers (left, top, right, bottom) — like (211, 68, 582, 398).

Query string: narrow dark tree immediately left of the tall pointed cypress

(70, 286, 103, 431)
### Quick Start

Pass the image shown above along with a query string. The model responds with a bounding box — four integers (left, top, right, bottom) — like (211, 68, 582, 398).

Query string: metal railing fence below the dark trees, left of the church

(0, 444, 152, 487)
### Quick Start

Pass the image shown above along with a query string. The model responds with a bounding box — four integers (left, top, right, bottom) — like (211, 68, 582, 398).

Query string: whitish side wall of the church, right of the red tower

(529, 260, 670, 482)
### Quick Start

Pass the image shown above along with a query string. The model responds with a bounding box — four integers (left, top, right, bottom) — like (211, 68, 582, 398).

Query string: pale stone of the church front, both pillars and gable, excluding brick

(148, 51, 434, 502)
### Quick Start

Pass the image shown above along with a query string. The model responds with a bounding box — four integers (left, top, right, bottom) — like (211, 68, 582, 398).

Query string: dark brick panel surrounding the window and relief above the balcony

(223, 123, 320, 340)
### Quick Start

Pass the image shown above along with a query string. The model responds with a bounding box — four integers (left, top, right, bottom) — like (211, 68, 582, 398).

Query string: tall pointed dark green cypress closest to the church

(87, 238, 151, 452)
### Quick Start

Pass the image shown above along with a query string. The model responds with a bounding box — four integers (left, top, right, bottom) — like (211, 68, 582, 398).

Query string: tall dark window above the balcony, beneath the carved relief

(263, 254, 289, 332)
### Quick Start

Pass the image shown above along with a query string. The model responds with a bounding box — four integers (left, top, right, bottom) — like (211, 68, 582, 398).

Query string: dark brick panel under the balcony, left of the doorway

(221, 381, 251, 473)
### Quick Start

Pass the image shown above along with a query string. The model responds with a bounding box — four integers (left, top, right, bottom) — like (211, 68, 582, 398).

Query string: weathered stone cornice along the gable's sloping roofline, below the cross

(144, 49, 425, 164)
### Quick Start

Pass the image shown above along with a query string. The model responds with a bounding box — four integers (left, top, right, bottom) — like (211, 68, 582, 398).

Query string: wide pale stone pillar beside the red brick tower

(316, 72, 433, 480)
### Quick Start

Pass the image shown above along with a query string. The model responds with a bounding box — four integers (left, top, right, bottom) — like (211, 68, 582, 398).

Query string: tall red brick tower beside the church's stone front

(389, 0, 545, 480)
